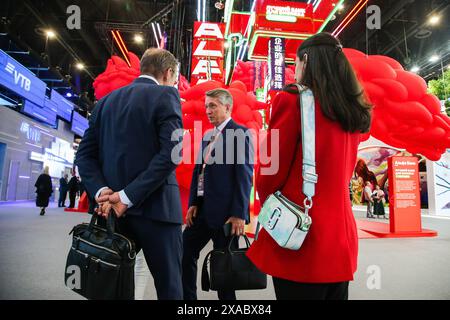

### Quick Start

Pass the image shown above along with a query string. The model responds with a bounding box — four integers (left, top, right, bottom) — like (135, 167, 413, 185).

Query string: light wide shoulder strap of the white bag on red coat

(295, 84, 318, 210)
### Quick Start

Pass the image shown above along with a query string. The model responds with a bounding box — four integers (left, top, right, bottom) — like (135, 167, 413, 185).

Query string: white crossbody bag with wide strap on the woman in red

(255, 84, 318, 250)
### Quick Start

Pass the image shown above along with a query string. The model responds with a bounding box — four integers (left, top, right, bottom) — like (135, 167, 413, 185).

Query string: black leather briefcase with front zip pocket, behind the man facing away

(64, 212, 136, 300)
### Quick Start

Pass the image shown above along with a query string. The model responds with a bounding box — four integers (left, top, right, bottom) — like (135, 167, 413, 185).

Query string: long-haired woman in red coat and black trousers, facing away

(248, 33, 371, 299)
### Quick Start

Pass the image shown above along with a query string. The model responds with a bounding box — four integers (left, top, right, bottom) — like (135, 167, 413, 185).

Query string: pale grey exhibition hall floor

(0, 202, 450, 300)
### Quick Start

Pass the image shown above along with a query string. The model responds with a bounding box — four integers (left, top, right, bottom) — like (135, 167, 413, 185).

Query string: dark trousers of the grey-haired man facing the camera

(183, 206, 238, 300)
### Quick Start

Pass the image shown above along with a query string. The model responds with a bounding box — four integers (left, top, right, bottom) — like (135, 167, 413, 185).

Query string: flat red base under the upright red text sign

(356, 219, 437, 239)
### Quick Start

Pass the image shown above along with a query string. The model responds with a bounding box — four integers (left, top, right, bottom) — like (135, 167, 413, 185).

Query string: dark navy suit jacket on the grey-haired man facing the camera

(189, 120, 253, 228)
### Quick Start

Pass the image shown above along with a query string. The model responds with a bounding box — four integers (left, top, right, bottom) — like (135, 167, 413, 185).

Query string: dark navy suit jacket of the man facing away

(76, 78, 182, 223)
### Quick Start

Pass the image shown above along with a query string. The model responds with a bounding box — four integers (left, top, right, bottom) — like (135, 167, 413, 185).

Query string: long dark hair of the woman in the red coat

(297, 32, 372, 133)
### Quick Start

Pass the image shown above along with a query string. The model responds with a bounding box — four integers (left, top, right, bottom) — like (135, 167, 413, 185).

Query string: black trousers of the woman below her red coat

(273, 277, 349, 300)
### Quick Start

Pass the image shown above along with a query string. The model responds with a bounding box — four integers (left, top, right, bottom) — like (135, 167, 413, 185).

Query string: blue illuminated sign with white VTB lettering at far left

(0, 50, 47, 107)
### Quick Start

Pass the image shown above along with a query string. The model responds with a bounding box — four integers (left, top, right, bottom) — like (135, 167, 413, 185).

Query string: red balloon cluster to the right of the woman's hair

(344, 49, 450, 161)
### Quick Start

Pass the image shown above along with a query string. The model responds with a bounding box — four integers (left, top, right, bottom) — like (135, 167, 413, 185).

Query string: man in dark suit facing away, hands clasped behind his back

(76, 49, 183, 299)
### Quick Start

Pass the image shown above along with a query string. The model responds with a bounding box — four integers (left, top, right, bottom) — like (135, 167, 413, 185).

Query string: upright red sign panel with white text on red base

(388, 156, 422, 233)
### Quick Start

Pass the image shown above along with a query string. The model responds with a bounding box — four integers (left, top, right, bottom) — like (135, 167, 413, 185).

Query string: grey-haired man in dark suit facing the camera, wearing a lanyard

(183, 89, 253, 300)
